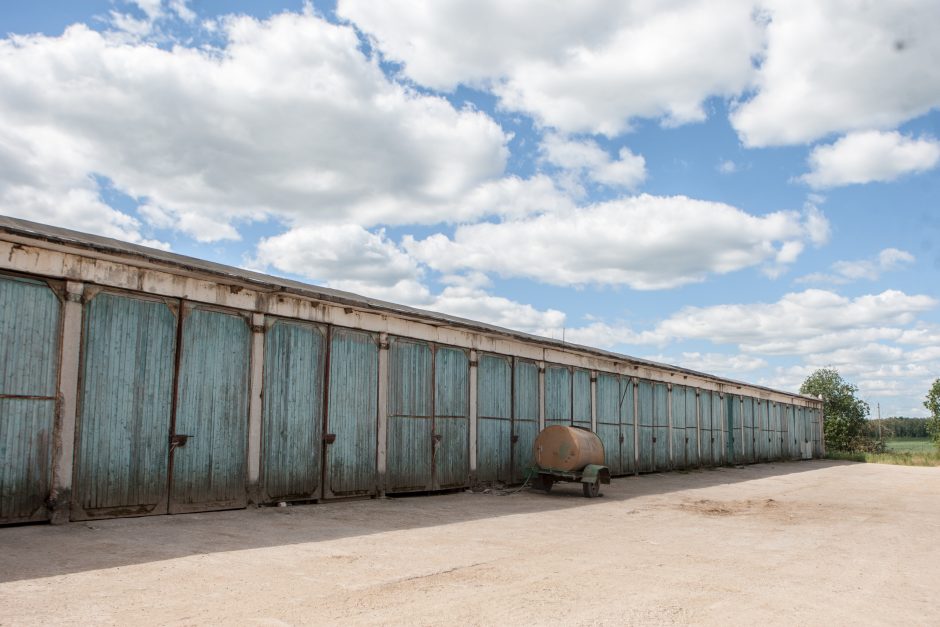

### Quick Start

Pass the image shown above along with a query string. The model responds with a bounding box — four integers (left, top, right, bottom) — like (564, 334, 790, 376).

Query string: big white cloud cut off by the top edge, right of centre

(337, 0, 762, 136)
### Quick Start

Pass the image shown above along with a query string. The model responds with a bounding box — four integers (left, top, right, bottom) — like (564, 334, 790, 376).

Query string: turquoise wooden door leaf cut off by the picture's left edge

(0, 276, 60, 523)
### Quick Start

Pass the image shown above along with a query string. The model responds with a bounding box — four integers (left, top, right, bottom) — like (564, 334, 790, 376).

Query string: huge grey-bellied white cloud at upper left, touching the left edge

(0, 14, 510, 240)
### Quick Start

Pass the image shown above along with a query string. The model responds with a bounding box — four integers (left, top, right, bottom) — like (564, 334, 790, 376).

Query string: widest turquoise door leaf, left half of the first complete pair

(71, 293, 177, 520)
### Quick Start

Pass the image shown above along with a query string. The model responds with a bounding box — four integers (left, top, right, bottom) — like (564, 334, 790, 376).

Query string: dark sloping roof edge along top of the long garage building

(0, 215, 819, 402)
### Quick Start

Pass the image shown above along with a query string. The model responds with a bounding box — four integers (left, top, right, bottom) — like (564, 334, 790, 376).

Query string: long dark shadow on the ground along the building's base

(0, 460, 852, 582)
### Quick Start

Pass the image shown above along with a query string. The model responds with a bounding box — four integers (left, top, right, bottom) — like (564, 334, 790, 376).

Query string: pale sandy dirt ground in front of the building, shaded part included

(0, 461, 940, 625)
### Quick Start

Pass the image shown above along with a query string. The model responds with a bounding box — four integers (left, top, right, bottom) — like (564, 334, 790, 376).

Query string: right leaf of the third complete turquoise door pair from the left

(433, 346, 470, 489)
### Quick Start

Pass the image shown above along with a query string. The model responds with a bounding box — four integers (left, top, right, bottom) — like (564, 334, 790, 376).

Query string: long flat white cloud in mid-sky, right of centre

(404, 194, 825, 289)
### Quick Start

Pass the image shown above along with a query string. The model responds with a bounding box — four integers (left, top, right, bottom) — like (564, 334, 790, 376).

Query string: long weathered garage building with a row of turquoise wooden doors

(0, 217, 824, 523)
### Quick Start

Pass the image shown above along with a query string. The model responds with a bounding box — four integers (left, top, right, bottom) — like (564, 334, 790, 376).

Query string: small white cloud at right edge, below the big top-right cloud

(800, 131, 940, 188)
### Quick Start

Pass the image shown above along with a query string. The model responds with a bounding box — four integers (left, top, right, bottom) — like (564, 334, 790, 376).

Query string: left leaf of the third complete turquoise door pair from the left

(385, 338, 434, 492)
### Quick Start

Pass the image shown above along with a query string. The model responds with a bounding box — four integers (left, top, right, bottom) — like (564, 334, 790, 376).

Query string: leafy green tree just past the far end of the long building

(800, 368, 874, 451)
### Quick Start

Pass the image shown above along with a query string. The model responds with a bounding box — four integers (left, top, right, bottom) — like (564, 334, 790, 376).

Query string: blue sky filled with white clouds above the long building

(0, 0, 940, 417)
